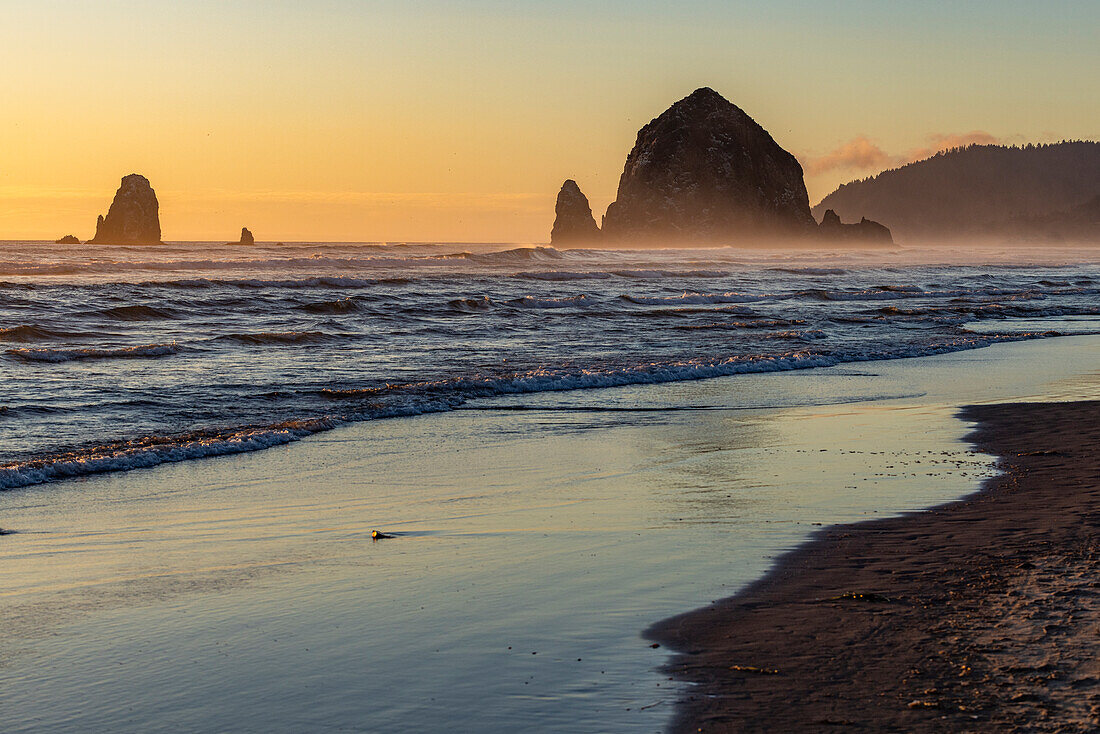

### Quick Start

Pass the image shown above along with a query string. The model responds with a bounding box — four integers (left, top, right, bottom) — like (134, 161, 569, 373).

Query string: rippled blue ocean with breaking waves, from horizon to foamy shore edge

(0, 242, 1100, 487)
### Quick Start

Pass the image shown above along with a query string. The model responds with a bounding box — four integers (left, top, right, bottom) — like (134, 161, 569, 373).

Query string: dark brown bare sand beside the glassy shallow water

(648, 402, 1100, 732)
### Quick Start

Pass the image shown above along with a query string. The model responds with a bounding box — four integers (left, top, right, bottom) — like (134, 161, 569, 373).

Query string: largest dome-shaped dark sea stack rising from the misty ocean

(603, 87, 816, 243)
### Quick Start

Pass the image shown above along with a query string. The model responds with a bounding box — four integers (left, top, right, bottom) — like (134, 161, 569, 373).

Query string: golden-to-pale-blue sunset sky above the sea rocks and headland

(0, 0, 1100, 242)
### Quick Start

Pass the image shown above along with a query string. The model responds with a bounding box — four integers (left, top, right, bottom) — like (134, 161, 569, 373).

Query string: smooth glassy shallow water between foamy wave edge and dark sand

(0, 337, 1100, 732)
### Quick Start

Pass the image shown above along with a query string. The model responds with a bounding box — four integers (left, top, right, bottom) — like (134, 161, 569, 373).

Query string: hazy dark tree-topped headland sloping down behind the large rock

(814, 141, 1100, 241)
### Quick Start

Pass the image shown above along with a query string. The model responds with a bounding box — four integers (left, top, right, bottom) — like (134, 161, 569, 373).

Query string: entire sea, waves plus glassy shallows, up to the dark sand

(0, 243, 1100, 734)
